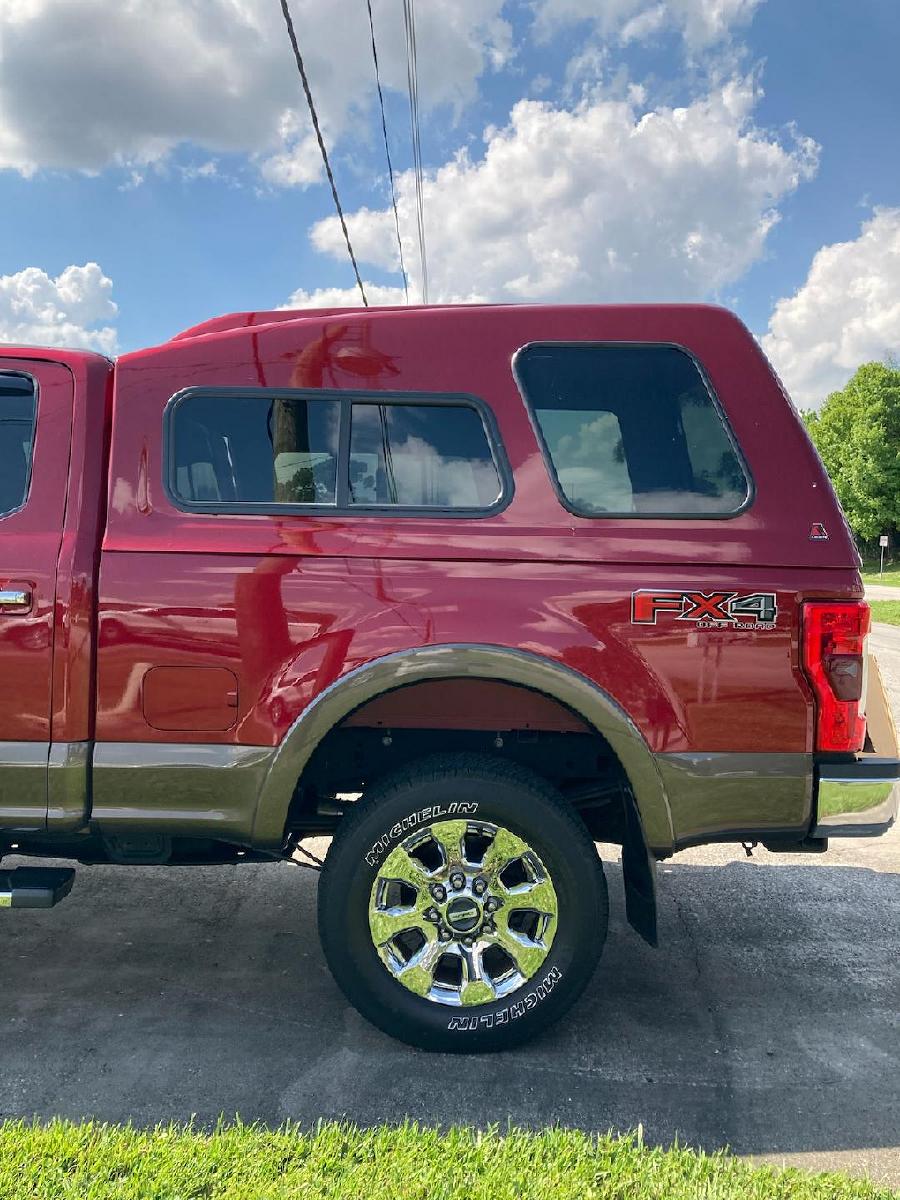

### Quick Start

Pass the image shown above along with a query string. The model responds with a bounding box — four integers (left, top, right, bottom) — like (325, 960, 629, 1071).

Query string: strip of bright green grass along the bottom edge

(0, 1121, 890, 1200)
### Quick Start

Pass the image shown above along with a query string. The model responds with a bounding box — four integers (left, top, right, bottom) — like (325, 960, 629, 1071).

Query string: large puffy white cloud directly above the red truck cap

(312, 80, 817, 301)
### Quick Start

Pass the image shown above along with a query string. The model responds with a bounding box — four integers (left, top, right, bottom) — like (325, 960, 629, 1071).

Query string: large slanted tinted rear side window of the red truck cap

(517, 346, 749, 516)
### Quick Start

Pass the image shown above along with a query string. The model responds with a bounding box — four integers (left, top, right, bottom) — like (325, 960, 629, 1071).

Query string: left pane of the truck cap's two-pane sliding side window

(170, 392, 341, 504)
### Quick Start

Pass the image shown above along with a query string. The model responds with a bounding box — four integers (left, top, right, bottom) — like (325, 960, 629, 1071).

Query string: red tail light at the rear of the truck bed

(803, 600, 871, 754)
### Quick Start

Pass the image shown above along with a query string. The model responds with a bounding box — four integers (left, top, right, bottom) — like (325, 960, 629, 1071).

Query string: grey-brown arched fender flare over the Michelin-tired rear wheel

(252, 644, 674, 854)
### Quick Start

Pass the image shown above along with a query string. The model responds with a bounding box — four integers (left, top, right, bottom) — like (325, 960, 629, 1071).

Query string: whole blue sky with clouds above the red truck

(0, 0, 900, 404)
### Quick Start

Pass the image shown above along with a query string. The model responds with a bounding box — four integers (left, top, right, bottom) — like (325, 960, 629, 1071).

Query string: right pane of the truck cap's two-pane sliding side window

(350, 403, 500, 509)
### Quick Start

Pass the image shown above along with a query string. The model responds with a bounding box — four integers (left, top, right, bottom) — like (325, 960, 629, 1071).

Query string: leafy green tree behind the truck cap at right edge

(803, 362, 900, 544)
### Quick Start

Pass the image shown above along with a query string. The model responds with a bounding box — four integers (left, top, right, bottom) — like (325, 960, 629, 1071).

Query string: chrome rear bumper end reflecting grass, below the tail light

(812, 758, 900, 838)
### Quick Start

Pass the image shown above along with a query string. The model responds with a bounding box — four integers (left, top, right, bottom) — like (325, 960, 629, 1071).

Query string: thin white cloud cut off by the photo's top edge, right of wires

(538, 0, 762, 53)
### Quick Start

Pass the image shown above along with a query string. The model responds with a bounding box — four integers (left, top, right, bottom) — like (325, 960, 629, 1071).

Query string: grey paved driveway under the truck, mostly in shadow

(0, 628, 900, 1186)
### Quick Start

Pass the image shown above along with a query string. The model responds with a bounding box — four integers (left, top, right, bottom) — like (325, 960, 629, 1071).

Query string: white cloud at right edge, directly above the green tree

(762, 209, 900, 408)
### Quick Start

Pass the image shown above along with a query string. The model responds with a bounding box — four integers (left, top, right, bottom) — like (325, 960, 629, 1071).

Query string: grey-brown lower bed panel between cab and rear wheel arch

(91, 742, 275, 841)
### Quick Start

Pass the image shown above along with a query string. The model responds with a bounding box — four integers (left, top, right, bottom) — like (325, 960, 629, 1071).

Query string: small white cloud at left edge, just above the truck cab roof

(0, 263, 118, 355)
